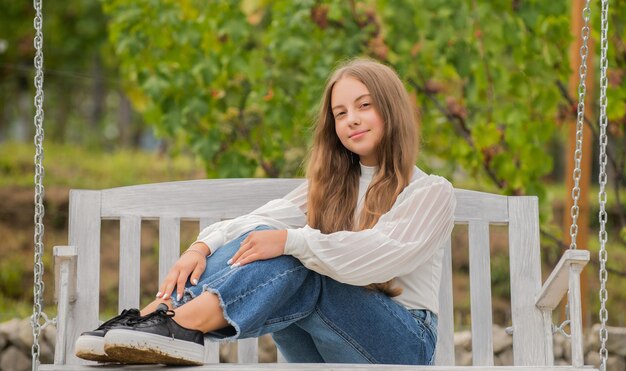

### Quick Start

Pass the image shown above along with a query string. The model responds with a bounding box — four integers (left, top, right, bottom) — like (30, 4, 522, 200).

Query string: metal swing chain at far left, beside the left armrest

(31, 0, 48, 371)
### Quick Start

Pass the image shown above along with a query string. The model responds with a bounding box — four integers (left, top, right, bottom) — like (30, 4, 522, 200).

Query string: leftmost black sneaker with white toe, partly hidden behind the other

(74, 308, 141, 362)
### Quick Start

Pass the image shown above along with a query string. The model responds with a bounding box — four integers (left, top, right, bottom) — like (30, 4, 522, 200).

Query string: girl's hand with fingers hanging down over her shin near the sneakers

(156, 242, 211, 300)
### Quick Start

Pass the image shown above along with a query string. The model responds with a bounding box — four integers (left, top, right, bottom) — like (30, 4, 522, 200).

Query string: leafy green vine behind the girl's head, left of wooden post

(103, 0, 570, 206)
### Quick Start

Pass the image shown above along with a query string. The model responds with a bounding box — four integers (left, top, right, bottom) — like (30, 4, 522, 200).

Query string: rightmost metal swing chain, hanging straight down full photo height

(598, 0, 609, 371)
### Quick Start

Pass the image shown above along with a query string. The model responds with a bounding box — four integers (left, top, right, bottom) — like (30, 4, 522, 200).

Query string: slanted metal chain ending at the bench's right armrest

(569, 0, 591, 249)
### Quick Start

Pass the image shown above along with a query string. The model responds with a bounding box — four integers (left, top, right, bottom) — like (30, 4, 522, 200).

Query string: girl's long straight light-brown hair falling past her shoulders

(307, 59, 418, 296)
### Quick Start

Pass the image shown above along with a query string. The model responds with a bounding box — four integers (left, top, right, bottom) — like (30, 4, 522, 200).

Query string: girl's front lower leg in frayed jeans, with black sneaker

(105, 227, 321, 364)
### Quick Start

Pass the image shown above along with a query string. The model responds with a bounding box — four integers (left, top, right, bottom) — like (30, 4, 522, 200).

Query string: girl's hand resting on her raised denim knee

(228, 230, 287, 268)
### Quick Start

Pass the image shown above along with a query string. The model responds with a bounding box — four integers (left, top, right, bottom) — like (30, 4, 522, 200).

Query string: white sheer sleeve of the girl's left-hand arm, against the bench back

(196, 182, 308, 253)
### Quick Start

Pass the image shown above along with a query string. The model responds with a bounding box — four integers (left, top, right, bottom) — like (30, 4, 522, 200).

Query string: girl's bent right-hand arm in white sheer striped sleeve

(285, 176, 456, 286)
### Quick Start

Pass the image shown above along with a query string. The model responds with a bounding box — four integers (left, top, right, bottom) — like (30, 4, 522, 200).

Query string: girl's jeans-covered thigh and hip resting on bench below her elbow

(275, 277, 437, 364)
